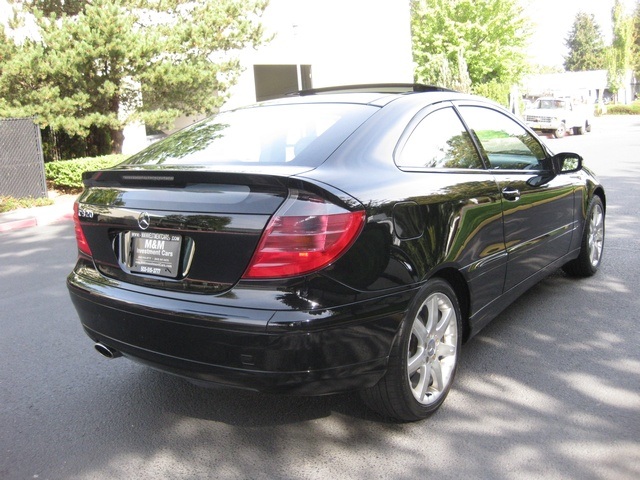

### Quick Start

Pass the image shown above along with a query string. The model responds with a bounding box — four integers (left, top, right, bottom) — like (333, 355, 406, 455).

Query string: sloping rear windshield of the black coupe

(123, 104, 378, 167)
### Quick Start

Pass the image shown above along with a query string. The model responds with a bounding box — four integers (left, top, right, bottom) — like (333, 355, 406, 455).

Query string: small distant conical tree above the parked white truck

(564, 12, 606, 72)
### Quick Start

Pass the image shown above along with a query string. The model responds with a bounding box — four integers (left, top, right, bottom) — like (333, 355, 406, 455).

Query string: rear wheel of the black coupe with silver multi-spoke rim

(361, 279, 462, 421)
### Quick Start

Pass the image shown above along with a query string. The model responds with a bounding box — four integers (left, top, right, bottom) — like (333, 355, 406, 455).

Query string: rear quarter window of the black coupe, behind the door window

(396, 107, 484, 168)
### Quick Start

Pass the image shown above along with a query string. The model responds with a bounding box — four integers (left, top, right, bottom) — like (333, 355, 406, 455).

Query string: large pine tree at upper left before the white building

(0, 0, 268, 153)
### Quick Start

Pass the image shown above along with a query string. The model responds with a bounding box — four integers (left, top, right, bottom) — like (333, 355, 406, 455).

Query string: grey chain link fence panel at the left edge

(0, 118, 47, 198)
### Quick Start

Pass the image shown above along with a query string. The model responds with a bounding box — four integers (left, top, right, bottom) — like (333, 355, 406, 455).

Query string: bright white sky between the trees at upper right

(521, 0, 636, 67)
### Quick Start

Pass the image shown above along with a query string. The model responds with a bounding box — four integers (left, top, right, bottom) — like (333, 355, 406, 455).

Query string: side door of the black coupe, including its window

(458, 105, 574, 291)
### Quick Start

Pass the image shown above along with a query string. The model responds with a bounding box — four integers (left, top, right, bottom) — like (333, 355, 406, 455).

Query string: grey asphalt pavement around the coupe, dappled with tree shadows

(0, 117, 640, 480)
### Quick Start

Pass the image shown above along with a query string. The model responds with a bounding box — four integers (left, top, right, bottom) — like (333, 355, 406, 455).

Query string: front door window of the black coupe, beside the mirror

(460, 106, 546, 170)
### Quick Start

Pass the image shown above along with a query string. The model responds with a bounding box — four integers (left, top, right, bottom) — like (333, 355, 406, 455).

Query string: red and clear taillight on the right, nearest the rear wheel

(243, 190, 365, 278)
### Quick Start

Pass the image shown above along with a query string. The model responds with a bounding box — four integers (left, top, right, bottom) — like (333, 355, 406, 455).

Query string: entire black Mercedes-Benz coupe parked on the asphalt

(68, 85, 606, 421)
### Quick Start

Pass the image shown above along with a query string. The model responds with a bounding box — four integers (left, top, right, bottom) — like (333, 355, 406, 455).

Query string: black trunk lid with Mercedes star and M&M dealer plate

(77, 167, 298, 293)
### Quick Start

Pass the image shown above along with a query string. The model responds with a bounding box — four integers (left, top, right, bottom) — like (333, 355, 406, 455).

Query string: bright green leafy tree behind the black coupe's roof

(411, 0, 531, 98)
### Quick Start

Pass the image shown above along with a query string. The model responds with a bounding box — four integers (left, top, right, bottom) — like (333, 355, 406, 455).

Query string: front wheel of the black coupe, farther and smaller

(562, 195, 605, 277)
